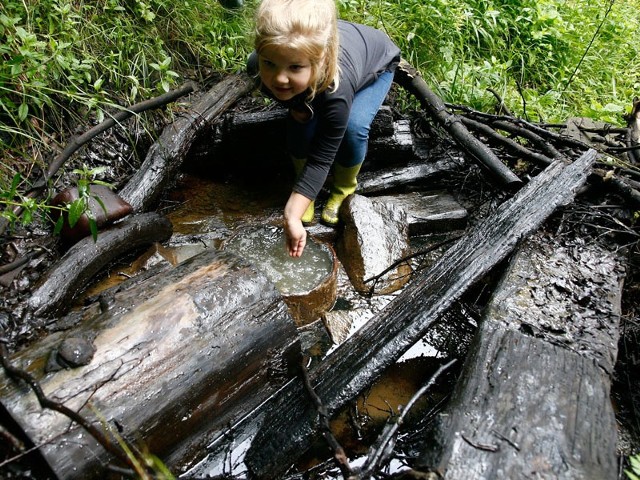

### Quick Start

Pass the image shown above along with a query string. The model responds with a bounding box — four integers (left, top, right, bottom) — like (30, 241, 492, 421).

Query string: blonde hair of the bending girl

(254, 0, 339, 100)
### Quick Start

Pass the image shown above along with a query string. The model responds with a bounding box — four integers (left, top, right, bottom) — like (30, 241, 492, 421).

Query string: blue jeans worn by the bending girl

(287, 72, 393, 168)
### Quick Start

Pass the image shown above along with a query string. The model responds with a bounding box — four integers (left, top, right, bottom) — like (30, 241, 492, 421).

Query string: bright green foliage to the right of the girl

(339, 0, 640, 124)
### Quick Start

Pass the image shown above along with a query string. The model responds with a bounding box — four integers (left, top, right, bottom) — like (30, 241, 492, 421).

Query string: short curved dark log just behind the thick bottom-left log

(28, 213, 173, 316)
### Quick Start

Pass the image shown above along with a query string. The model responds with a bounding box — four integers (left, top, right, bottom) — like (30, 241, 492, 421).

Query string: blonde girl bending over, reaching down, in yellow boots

(248, 0, 400, 257)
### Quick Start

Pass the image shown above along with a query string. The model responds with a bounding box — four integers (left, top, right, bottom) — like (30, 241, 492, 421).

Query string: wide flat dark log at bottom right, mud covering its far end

(414, 235, 624, 480)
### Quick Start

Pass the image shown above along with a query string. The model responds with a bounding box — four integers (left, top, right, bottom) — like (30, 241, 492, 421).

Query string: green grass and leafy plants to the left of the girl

(0, 0, 254, 188)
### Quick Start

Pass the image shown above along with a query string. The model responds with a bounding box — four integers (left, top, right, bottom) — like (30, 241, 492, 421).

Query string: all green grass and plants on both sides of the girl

(0, 0, 640, 189)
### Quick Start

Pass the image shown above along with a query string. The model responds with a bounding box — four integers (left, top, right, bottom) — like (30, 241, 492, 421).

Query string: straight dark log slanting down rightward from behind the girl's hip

(395, 61, 522, 187)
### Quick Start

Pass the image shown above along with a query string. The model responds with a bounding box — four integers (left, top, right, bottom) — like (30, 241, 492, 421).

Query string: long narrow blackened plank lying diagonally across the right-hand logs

(245, 150, 596, 478)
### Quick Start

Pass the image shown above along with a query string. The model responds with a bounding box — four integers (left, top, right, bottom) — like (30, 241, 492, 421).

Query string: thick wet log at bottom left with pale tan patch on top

(0, 250, 300, 480)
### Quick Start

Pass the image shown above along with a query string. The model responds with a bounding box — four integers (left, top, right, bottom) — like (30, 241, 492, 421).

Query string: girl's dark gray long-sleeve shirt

(248, 20, 400, 199)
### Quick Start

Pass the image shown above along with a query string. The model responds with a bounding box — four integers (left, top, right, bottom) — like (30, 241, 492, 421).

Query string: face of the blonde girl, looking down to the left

(259, 46, 311, 101)
